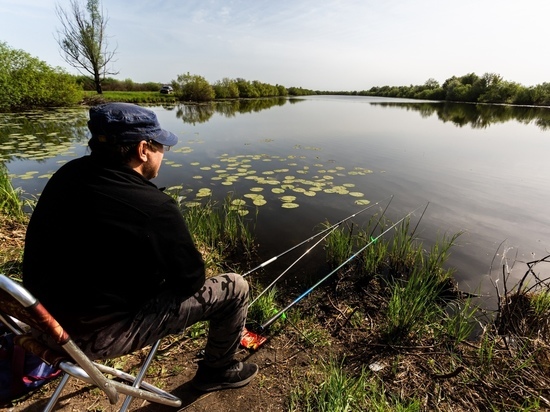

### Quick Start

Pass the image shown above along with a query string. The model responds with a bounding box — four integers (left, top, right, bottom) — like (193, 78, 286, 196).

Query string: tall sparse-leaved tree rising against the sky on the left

(55, 0, 118, 94)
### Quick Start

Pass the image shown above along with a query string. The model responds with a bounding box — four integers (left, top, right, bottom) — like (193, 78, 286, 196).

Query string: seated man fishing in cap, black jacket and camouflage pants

(23, 103, 258, 391)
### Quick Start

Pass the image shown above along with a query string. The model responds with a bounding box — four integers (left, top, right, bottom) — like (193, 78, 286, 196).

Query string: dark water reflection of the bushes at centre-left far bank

(176, 97, 295, 124)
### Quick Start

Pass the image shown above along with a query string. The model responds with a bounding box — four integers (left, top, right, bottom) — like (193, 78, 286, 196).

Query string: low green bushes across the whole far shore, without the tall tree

(0, 42, 550, 112)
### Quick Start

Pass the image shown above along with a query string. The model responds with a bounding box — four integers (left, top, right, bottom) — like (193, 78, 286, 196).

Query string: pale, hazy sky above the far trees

(0, 0, 550, 91)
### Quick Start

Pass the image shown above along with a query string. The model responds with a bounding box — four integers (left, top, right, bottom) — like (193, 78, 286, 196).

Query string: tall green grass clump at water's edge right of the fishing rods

(326, 219, 475, 344)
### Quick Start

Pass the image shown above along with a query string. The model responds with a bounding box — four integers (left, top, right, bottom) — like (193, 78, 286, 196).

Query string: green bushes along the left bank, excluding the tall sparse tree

(0, 42, 315, 112)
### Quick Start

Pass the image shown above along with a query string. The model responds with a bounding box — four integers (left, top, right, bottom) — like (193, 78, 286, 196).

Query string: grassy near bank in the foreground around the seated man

(0, 163, 550, 412)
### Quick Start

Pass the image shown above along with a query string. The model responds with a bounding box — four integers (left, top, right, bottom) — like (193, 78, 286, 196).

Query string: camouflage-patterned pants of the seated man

(73, 273, 249, 367)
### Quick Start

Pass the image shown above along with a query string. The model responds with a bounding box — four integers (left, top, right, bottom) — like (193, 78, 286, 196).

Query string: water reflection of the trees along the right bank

(371, 102, 550, 130)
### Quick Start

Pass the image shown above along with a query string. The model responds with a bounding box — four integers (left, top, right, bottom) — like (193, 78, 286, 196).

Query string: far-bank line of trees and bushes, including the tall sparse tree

(4, 0, 550, 111)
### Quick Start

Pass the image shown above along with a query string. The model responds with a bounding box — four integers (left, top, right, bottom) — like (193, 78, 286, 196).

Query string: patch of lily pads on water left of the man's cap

(0, 109, 89, 162)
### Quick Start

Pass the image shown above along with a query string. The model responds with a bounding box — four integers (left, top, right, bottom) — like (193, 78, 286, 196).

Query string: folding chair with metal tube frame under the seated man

(0, 274, 181, 411)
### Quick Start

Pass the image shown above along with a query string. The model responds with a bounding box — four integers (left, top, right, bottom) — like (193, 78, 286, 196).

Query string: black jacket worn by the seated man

(23, 156, 205, 332)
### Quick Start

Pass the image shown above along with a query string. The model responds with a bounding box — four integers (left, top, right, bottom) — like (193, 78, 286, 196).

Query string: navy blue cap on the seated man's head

(88, 103, 178, 146)
